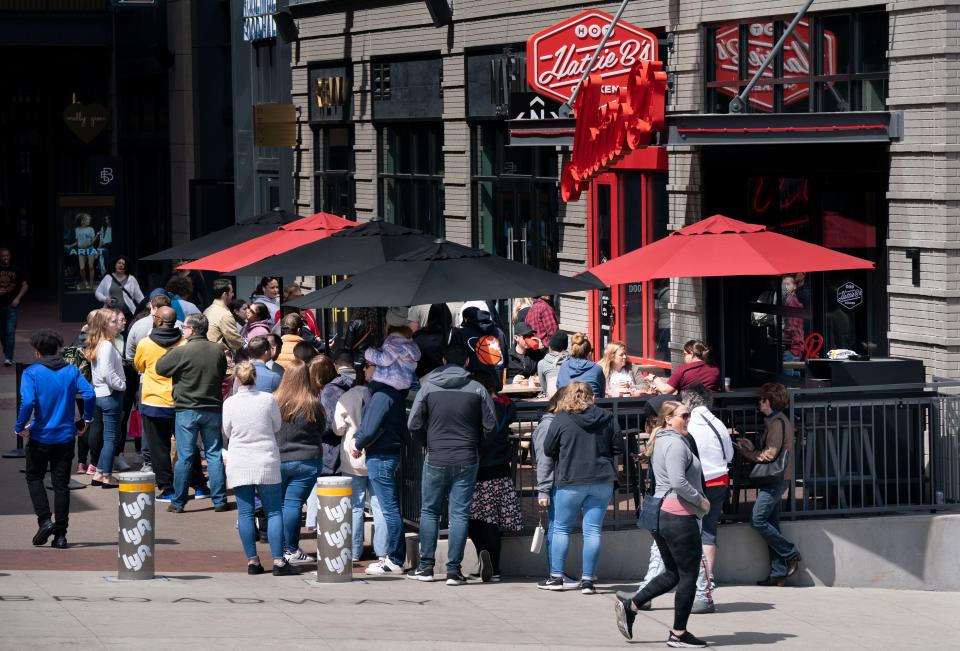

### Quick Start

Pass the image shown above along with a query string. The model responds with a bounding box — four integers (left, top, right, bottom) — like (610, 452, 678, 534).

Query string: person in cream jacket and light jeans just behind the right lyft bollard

(333, 363, 387, 567)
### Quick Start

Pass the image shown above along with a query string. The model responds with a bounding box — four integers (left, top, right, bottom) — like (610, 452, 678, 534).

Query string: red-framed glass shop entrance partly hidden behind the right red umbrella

(587, 147, 670, 367)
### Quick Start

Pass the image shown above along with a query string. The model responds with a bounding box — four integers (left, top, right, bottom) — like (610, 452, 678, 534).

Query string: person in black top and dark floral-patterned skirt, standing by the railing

(467, 372, 523, 583)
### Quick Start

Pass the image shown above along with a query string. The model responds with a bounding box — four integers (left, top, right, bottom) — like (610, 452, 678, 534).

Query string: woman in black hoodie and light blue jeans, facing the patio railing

(537, 382, 623, 594)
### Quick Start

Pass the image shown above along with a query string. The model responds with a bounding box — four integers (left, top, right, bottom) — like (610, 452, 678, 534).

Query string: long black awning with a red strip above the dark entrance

(667, 111, 903, 146)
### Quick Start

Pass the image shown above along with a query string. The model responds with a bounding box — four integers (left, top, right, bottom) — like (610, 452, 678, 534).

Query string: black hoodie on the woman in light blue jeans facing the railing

(543, 405, 623, 487)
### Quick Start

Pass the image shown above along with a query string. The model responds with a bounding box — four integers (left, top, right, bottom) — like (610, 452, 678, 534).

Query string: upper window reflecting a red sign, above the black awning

(706, 10, 888, 113)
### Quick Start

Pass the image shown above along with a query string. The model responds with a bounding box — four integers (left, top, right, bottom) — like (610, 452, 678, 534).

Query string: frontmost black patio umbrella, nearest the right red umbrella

(288, 236, 604, 308)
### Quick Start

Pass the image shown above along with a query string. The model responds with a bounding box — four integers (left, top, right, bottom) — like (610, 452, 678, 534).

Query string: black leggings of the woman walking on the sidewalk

(633, 511, 703, 631)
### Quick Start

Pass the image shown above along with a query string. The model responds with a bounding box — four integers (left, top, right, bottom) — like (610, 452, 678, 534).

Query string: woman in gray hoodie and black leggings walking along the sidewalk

(616, 400, 710, 648)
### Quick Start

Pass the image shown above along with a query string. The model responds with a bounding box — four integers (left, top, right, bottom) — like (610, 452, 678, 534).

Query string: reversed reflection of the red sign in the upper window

(714, 20, 837, 112)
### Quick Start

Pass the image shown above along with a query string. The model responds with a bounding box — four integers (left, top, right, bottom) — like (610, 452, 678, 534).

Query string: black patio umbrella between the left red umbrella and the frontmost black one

(233, 217, 433, 277)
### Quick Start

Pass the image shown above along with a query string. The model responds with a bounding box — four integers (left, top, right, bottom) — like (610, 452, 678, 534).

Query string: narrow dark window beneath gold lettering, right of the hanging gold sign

(313, 126, 356, 219)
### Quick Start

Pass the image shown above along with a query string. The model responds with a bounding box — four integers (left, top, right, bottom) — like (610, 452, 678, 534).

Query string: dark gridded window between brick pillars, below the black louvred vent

(377, 124, 443, 237)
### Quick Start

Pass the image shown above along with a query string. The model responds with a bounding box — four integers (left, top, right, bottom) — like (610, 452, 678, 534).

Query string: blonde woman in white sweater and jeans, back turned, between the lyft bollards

(223, 362, 300, 576)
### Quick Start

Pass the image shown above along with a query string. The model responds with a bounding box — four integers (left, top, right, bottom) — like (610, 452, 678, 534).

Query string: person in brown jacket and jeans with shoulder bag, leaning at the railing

(735, 382, 800, 586)
